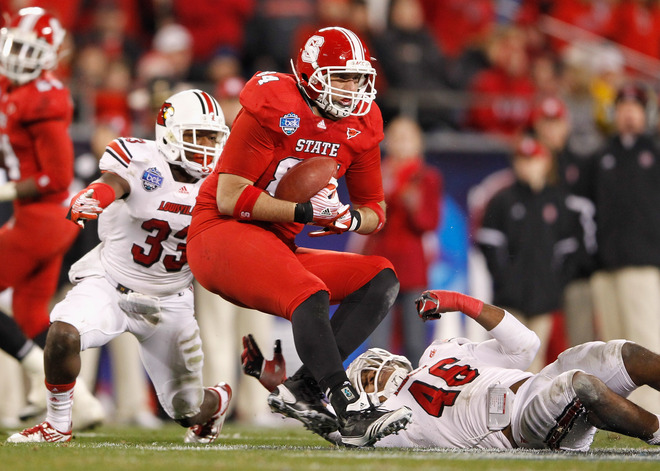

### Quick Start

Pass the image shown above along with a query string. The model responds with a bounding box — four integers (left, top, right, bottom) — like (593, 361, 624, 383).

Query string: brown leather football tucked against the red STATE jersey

(275, 157, 337, 203)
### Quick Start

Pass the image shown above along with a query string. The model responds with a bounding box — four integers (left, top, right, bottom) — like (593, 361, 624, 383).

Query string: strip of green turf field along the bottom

(0, 421, 660, 471)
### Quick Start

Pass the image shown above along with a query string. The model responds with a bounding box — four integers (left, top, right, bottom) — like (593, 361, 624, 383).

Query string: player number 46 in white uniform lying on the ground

(244, 290, 660, 451)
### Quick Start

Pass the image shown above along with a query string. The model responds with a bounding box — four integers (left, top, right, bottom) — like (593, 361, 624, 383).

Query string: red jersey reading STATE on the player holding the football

(189, 72, 384, 245)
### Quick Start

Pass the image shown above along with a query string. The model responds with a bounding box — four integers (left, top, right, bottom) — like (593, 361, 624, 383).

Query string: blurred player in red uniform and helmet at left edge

(0, 7, 78, 347)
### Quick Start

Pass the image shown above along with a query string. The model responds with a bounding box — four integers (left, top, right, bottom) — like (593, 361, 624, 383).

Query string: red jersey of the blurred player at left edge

(0, 73, 74, 209)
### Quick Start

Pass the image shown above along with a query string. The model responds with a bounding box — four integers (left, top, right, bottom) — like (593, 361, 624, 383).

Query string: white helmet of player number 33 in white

(156, 90, 229, 178)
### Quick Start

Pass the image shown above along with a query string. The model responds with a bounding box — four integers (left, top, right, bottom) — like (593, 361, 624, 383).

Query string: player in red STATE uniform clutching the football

(188, 27, 410, 446)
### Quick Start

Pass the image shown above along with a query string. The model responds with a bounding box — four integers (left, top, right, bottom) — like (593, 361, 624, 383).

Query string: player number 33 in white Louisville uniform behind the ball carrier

(8, 90, 231, 443)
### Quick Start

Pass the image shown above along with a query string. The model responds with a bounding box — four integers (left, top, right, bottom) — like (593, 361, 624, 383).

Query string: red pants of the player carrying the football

(187, 220, 393, 320)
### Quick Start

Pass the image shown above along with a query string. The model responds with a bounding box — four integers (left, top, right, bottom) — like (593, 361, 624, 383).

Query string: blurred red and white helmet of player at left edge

(0, 7, 66, 84)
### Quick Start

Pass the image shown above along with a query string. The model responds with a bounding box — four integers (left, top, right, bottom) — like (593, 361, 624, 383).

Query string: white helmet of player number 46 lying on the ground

(346, 348, 413, 404)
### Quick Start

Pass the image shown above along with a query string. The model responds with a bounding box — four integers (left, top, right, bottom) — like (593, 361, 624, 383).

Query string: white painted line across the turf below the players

(55, 440, 660, 462)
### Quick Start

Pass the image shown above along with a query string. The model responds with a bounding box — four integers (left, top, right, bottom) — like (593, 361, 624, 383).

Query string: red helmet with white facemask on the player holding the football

(291, 27, 376, 118)
